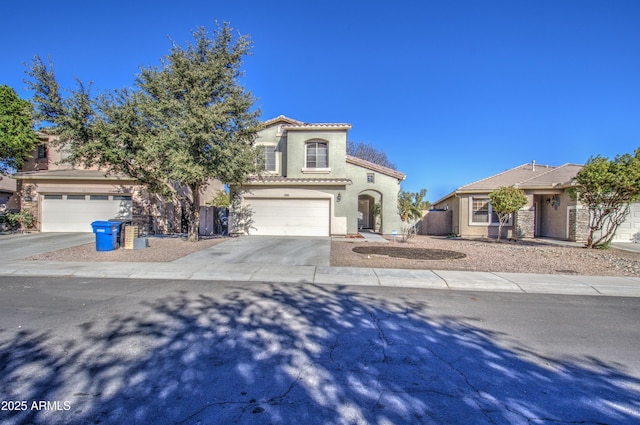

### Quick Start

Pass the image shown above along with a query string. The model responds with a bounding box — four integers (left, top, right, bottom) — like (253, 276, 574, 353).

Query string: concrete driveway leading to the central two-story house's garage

(174, 236, 331, 266)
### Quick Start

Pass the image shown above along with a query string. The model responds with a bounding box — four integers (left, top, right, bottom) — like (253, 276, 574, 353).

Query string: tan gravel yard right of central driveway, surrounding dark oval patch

(331, 236, 640, 277)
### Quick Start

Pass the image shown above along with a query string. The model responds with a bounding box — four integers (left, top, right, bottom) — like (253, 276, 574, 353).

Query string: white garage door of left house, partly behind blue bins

(40, 194, 132, 232)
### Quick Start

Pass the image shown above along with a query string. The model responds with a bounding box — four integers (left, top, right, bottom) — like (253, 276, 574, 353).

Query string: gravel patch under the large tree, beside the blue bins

(26, 237, 229, 263)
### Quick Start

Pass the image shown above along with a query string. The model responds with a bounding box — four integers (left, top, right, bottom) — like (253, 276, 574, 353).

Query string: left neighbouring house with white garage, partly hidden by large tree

(14, 133, 223, 233)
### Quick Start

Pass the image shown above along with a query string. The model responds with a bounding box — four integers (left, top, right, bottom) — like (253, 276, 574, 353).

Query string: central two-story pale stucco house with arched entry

(230, 115, 405, 236)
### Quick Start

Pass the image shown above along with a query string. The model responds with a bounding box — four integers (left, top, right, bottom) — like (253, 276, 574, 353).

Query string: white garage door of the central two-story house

(247, 199, 329, 236)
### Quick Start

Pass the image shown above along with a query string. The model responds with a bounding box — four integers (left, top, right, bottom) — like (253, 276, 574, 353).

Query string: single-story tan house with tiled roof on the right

(426, 162, 640, 242)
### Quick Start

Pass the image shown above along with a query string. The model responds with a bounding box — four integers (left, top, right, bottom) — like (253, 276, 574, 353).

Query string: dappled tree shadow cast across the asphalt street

(0, 284, 640, 424)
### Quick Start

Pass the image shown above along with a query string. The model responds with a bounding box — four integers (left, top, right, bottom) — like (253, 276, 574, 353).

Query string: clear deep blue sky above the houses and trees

(0, 0, 640, 201)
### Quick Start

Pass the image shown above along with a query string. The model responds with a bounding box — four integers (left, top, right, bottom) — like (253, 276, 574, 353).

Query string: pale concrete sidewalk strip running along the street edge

(0, 260, 640, 297)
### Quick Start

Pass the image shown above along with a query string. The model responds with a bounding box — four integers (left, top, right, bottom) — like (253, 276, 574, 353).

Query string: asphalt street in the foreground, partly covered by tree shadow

(0, 276, 640, 424)
